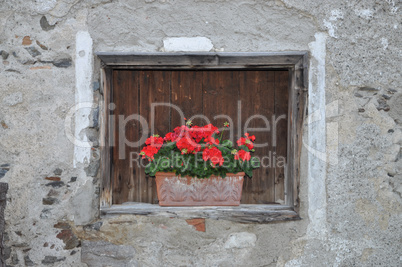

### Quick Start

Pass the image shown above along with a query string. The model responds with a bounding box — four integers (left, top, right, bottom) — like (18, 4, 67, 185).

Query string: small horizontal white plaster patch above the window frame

(163, 37, 214, 52)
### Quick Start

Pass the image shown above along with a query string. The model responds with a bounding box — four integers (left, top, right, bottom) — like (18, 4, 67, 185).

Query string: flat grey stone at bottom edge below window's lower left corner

(81, 241, 138, 267)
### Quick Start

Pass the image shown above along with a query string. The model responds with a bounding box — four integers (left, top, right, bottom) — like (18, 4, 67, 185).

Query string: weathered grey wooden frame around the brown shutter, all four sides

(96, 51, 308, 223)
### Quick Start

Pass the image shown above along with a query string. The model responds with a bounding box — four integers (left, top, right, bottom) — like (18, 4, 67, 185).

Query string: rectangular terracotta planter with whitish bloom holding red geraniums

(155, 172, 244, 206)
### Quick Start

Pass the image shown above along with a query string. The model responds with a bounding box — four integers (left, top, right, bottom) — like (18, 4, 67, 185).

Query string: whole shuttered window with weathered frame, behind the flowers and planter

(98, 53, 307, 222)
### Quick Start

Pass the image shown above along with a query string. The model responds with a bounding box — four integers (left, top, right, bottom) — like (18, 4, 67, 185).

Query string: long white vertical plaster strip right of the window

(305, 33, 327, 240)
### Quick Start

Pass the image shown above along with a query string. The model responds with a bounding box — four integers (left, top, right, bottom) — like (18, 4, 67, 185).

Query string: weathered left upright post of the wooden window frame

(99, 68, 112, 207)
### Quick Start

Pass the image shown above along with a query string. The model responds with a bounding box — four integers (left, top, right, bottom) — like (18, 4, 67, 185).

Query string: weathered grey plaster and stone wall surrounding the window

(0, 0, 402, 266)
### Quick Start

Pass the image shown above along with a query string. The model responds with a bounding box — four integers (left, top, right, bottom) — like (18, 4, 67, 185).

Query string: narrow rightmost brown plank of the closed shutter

(272, 71, 289, 204)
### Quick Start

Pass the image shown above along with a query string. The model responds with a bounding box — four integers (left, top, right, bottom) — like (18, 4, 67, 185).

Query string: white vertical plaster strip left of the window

(74, 31, 93, 167)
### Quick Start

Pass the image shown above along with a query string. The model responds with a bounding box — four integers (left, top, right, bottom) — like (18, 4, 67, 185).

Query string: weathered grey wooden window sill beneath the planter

(101, 202, 301, 223)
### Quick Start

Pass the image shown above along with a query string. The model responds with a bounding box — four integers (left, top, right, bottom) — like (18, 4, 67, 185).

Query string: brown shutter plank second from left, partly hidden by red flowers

(138, 70, 172, 203)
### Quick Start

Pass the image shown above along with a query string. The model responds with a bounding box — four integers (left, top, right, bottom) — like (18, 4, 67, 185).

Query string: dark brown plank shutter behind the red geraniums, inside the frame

(111, 70, 289, 204)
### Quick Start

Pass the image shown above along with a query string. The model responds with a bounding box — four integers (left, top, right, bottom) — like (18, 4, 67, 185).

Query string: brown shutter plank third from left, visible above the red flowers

(171, 71, 205, 126)
